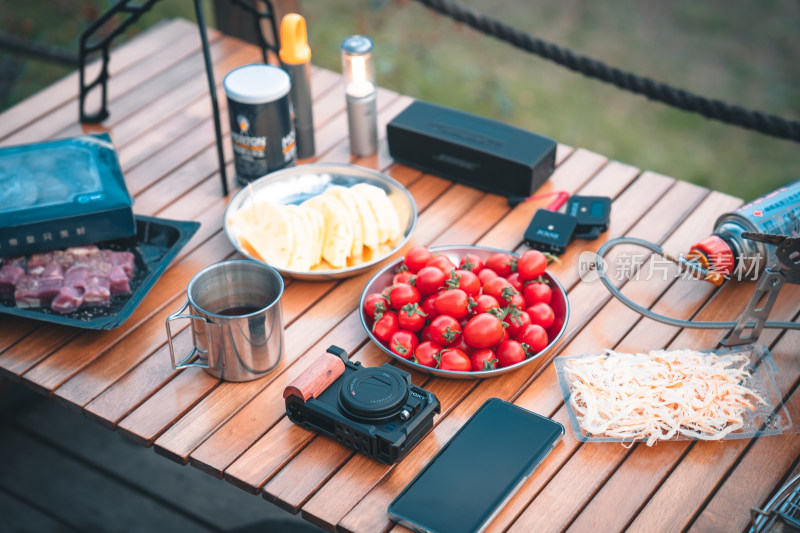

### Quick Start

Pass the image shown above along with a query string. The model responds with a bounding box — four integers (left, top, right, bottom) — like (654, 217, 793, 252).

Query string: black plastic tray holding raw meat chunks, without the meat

(0, 215, 200, 330)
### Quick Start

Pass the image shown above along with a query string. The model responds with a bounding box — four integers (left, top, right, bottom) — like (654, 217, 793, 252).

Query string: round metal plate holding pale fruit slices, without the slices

(223, 163, 417, 280)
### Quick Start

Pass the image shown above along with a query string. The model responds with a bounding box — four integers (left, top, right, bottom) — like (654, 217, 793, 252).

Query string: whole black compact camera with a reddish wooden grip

(283, 346, 440, 464)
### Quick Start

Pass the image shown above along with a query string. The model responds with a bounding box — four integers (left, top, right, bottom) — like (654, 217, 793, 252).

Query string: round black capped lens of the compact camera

(339, 367, 408, 420)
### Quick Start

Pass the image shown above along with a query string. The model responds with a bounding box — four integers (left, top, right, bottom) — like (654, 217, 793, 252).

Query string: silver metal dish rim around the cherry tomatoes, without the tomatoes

(358, 245, 569, 379)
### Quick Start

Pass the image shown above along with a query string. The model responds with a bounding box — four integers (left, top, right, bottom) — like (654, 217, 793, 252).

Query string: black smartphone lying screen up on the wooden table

(389, 398, 564, 533)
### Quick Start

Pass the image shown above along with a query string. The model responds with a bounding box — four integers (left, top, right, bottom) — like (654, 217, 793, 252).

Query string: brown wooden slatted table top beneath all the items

(0, 20, 800, 532)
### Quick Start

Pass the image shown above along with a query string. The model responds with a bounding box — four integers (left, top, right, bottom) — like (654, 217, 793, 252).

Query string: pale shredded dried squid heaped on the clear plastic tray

(564, 350, 767, 446)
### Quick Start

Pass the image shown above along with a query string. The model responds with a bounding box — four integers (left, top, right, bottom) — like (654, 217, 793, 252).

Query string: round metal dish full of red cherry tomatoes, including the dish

(359, 246, 569, 379)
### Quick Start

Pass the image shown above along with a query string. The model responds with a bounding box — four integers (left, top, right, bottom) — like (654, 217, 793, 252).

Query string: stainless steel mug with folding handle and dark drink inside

(166, 259, 284, 381)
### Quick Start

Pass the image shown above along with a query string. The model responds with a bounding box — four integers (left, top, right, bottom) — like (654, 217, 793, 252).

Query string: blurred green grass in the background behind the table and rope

(0, 0, 800, 199)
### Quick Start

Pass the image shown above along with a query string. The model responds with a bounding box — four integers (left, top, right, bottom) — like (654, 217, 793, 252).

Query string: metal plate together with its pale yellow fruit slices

(224, 163, 417, 280)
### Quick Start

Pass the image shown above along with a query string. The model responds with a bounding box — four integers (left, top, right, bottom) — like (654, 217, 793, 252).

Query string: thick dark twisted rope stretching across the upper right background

(417, 0, 800, 142)
